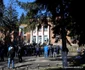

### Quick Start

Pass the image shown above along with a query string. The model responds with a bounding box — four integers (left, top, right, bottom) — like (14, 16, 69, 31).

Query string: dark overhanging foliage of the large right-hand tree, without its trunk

(18, 0, 85, 46)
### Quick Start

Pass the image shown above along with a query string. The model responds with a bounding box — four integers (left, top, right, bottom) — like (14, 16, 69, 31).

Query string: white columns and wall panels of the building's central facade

(30, 26, 50, 44)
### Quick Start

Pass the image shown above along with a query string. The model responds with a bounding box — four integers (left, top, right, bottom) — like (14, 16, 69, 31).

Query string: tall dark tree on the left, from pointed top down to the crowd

(2, 0, 18, 45)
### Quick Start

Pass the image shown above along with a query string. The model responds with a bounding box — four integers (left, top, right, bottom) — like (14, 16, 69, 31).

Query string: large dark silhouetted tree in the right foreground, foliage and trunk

(16, 0, 85, 66)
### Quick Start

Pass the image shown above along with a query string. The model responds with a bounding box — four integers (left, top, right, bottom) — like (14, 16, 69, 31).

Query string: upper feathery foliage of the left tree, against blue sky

(3, 5, 18, 30)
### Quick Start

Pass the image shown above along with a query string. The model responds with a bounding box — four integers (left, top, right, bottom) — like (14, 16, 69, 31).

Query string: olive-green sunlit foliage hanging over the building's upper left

(20, 7, 37, 32)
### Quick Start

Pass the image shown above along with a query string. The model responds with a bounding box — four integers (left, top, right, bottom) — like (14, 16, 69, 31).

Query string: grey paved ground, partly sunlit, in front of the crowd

(0, 54, 77, 70)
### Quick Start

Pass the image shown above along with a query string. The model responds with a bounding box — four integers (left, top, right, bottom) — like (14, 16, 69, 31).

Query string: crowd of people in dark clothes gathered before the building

(0, 41, 60, 68)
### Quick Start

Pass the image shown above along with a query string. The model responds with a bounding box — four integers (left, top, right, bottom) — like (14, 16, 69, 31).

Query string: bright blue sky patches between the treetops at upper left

(3, 0, 34, 19)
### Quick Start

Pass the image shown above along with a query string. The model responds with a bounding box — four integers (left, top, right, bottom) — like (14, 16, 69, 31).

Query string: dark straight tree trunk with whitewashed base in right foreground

(61, 27, 68, 67)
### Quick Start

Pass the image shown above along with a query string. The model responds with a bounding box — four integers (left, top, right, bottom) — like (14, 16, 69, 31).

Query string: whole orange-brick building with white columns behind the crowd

(19, 21, 71, 44)
